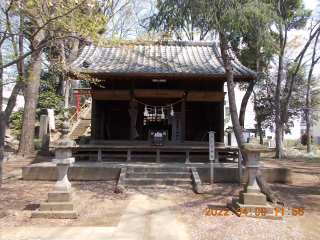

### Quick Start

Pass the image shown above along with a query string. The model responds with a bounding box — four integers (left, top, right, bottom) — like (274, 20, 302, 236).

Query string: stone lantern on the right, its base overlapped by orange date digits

(228, 137, 275, 218)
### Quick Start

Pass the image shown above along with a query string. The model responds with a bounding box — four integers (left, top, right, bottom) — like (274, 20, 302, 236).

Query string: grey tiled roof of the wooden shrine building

(71, 42, 255, 76)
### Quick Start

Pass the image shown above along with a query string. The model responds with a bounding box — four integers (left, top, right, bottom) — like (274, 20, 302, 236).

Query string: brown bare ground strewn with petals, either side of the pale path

(0, 151, 320, 239)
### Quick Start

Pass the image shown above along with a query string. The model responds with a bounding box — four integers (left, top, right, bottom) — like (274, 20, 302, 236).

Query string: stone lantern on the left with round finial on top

(31, 121, 86, 218)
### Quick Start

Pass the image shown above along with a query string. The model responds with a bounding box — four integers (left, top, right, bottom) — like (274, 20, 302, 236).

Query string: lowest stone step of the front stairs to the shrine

(125, 178, 192, 187)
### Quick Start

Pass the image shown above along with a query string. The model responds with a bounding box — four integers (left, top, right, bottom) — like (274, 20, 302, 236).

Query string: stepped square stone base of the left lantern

(31, 188, 86, 219)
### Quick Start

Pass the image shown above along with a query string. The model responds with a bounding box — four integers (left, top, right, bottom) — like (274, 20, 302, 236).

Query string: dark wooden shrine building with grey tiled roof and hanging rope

(70, 42, 255, 162)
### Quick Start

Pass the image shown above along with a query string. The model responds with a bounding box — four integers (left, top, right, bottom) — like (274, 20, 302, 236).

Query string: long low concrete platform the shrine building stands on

(22, 161, 292, 184)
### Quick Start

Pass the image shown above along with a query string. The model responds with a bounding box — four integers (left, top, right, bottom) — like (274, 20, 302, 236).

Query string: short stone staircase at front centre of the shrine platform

(124, 167, 192, 188)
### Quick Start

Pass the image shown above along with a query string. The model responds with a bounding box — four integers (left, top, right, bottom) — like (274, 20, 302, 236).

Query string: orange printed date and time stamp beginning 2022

(205, 207, 304, 216)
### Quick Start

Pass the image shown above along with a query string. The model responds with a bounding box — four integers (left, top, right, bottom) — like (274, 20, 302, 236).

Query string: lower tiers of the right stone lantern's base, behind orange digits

(227, 198, 283, 220)
